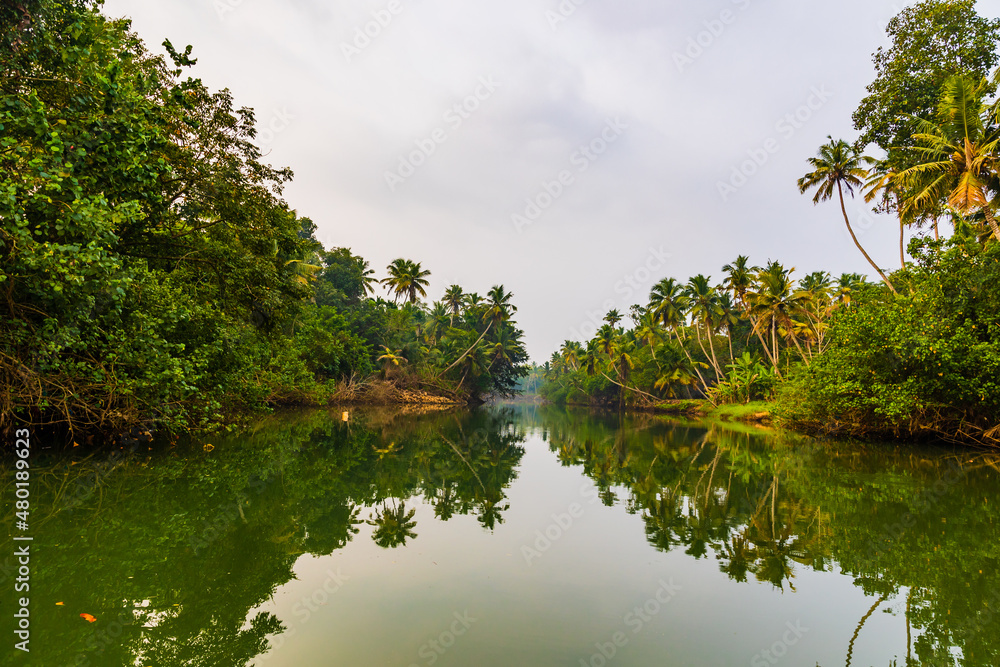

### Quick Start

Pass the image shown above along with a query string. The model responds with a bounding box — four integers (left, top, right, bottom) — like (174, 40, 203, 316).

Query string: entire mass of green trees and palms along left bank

(0, 0, 526, 433)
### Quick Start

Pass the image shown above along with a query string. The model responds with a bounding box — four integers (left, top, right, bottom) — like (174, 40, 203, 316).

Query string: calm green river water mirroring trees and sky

(0, 407, 1000, 667)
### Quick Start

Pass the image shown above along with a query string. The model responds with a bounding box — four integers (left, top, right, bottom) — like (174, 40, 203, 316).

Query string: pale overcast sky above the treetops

(104, 0, 1000, 362)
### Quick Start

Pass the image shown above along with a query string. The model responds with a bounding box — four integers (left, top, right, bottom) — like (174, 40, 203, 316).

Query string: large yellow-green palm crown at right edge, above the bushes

(898, 75, 1000, 241)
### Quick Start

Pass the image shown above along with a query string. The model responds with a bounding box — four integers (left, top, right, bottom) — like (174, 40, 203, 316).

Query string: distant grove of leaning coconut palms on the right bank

(540, 256, 865, 406)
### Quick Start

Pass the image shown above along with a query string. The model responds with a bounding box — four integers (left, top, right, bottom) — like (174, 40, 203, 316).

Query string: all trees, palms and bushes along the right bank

(541, 0, 1000, 444)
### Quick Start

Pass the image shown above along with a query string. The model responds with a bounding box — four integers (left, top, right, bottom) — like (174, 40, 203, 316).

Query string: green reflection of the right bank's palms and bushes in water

(532, 408, 1000, 667)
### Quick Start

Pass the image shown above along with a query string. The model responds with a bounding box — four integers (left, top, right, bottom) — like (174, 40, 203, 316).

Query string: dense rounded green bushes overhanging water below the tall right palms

(781, 240, 1000, 438)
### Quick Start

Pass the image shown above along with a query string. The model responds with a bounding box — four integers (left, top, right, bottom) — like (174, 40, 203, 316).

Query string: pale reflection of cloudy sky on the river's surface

(251, 435, 906, 667)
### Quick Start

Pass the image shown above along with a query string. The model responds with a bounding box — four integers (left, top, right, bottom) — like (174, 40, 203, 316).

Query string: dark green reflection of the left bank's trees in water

(0, 410, 524, 667)
